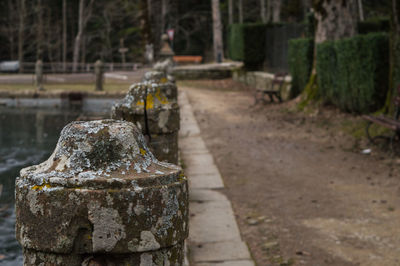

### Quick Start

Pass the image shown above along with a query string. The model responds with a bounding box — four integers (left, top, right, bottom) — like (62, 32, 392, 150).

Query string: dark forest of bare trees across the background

(0, 0, 390, 63)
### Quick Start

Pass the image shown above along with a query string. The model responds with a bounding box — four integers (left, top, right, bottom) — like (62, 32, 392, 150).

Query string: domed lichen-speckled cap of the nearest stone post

(19, 119, 181, 188)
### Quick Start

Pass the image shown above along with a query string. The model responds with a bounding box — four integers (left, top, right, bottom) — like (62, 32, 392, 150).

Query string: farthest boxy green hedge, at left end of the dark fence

(228, 23, 266, 68)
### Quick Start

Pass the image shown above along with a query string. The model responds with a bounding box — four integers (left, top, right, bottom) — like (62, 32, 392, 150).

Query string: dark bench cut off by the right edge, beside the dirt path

(363, 86, 400, 153)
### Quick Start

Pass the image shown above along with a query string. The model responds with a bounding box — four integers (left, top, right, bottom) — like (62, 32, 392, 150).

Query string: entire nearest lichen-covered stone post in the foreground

(16, 120, 188, 266)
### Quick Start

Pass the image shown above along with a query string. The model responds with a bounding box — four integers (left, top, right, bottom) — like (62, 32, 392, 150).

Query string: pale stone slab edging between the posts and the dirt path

(178, 91, 254, 266)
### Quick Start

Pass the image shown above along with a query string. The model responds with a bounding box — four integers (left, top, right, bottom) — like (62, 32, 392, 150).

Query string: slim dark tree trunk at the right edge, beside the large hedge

(384, 0, 400, 114)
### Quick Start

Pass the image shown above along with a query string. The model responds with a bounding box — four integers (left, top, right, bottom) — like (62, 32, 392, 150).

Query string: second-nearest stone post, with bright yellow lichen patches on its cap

(111, 75, 179, 164)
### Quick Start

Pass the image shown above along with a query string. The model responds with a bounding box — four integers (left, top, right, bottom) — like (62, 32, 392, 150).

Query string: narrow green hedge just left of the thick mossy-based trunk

(288, 38, 314, 97)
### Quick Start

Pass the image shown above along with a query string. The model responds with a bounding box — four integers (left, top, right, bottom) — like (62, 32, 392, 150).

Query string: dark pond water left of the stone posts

(0, 104, 110, 266)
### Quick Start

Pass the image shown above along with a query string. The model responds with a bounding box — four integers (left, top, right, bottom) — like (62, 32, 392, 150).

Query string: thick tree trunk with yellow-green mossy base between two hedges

(300, 0, 357, 106)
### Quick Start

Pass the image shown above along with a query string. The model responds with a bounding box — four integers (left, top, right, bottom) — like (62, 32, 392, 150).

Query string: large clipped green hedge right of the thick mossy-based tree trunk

(316, 33, 389, 113)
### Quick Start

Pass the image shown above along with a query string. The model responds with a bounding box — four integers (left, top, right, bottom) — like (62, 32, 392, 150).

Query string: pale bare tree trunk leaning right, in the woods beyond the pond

(72, 0, 94, 72)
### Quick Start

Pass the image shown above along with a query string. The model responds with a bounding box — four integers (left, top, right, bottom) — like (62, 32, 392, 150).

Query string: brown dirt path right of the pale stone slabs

(182, 82, 400, 266)
